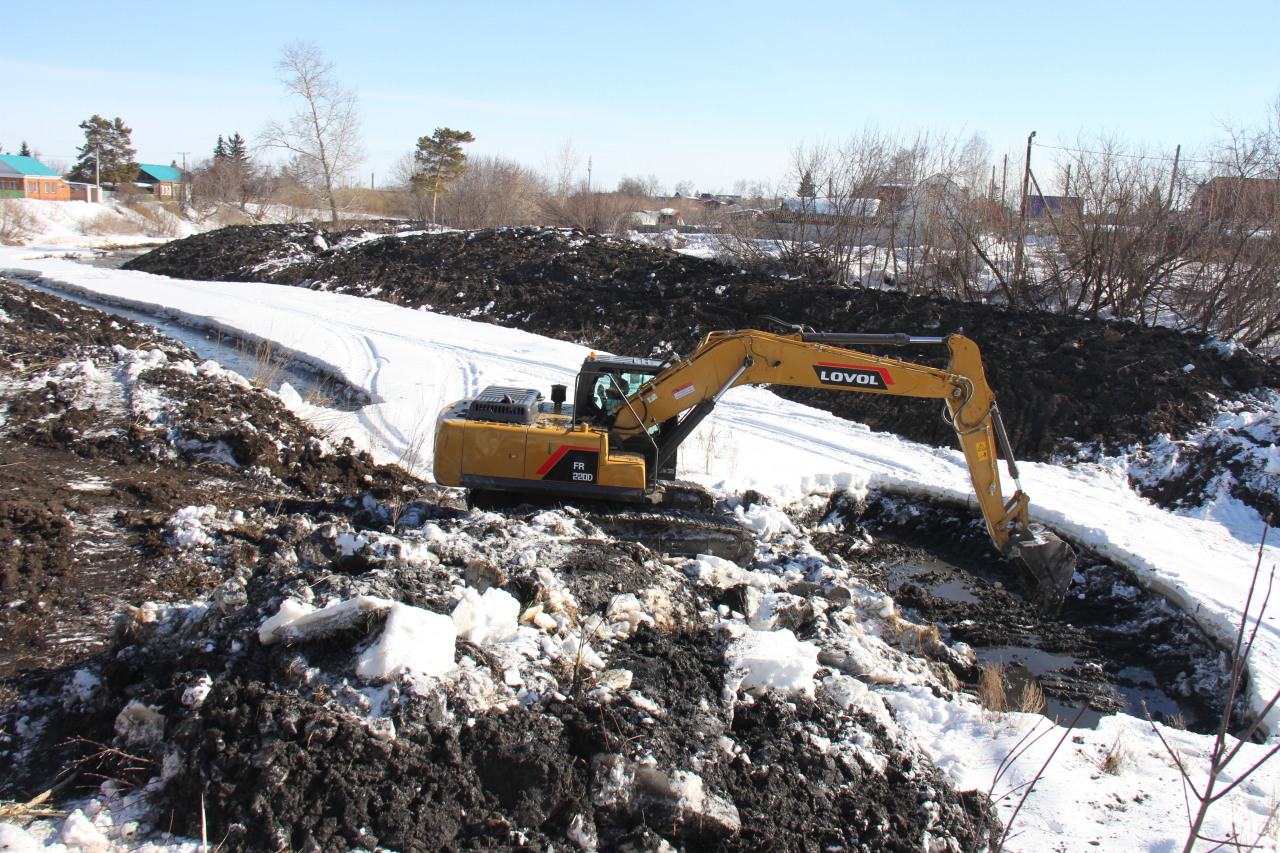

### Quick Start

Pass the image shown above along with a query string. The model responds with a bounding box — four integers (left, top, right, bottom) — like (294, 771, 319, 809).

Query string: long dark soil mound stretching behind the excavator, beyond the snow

(127, 225, 1280, 459)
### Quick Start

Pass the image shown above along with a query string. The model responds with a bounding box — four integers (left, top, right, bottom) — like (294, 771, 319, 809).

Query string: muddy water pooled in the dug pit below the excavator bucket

(884, 556, 1201, 729)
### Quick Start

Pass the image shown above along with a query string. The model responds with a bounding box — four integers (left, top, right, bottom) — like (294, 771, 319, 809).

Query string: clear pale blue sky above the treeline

(0, 0, 1280, 191)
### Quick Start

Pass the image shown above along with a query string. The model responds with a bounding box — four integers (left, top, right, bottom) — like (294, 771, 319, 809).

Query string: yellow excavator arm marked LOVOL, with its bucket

(612, 330, 1075, 612)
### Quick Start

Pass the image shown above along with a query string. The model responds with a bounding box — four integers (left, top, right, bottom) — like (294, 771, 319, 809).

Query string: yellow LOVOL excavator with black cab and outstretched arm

(435, 324, 1075, 615)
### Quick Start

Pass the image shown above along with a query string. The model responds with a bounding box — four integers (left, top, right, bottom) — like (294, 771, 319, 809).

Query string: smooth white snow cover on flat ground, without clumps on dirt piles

(0, 227, 1280, 852)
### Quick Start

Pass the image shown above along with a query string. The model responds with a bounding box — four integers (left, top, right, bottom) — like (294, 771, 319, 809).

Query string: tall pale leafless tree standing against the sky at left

(259, 41, 365, 222)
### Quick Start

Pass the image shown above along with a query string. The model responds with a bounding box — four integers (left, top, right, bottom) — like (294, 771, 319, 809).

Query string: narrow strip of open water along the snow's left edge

(19, 248, 370, 411)
